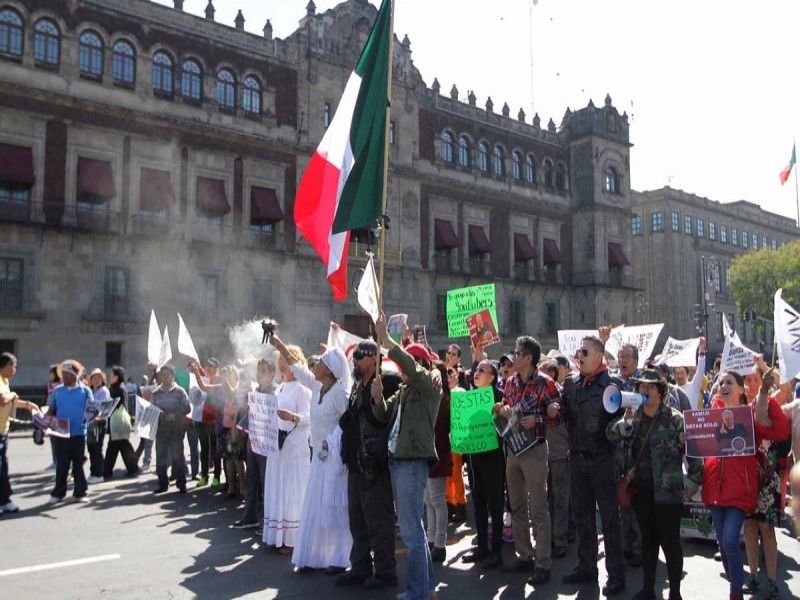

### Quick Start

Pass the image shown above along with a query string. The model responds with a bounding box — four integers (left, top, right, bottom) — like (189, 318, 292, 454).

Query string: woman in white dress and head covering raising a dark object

(272, 336, 353, 575)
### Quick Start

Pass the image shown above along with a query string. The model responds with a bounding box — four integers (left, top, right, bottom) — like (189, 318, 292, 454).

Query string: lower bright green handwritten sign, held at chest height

(450, 387, 500, 454)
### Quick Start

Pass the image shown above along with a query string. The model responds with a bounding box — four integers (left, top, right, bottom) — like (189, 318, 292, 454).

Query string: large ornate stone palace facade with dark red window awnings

(0, 0, 642, 384)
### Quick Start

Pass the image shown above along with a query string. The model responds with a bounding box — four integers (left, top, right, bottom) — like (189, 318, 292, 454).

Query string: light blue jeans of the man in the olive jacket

(389, 460, 436, 600)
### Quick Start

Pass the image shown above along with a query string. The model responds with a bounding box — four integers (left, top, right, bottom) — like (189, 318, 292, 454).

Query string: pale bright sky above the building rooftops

(156, 0, 800, 219)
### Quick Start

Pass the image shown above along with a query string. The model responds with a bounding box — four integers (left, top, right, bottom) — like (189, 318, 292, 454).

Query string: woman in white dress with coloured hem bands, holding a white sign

(262, 346, 311, 555)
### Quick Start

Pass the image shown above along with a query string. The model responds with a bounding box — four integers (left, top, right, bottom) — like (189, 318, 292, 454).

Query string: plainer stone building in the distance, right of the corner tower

(631, 187, 798, 354)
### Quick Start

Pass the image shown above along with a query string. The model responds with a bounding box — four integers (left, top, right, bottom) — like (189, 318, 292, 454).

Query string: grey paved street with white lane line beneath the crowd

(0, 434, 800, 600)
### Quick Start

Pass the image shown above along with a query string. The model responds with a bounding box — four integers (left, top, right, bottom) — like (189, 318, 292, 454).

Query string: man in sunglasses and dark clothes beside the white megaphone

(548, 336, 625, 596)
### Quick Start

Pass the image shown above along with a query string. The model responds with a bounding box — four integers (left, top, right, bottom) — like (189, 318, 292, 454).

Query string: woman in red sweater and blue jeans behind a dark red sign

(702, 370, 789, 600)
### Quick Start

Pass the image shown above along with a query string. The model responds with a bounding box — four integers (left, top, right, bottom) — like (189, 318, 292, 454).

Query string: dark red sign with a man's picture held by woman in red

(683, 406, 756, 458)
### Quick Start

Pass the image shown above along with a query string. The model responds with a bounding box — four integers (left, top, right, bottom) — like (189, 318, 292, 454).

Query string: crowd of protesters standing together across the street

(0, 316, 800, 600)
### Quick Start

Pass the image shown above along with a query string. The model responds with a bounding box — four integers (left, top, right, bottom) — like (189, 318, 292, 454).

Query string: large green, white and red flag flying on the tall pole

(294, 0, 393, 300)
